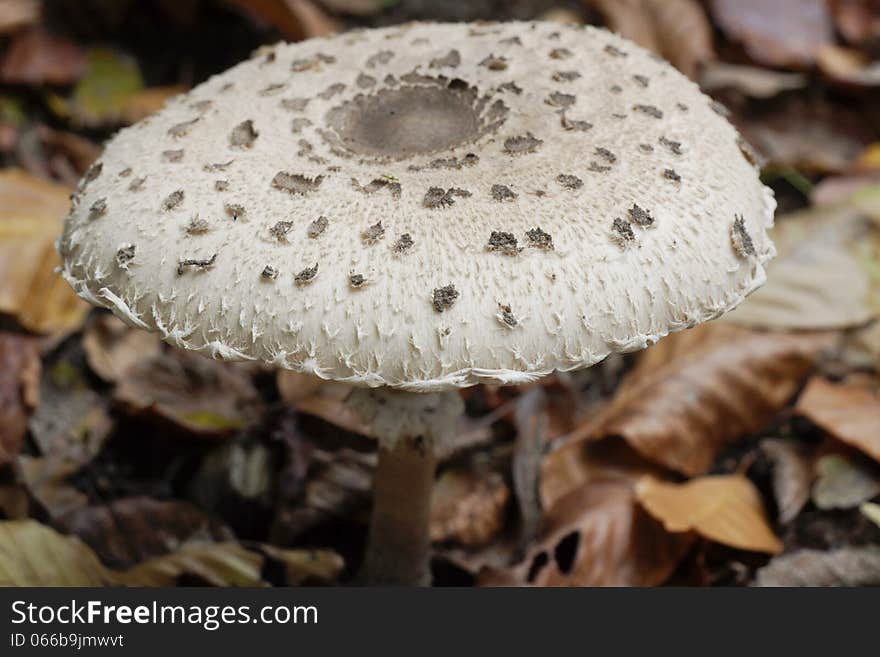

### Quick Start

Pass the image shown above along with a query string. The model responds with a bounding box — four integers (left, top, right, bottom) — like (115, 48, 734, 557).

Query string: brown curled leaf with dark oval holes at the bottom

(480, 479, 692, 586)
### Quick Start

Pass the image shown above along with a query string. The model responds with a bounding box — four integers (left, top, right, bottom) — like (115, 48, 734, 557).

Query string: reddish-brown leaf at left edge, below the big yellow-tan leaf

(0, 332, 40, 466)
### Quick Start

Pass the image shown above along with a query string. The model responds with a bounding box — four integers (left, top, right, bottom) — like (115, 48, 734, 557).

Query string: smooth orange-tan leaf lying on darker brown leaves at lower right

(636, 475, 782, 554)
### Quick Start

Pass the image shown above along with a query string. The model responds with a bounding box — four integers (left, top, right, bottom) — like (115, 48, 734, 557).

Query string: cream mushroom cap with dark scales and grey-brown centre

(59, 22, 775, 391)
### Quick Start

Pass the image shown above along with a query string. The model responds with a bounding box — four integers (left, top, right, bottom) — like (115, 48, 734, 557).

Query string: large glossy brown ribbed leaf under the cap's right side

(571, 322, 829, 476)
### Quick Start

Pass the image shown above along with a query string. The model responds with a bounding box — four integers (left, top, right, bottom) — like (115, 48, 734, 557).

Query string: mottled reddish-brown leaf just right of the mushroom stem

(430, 469, 510, 548)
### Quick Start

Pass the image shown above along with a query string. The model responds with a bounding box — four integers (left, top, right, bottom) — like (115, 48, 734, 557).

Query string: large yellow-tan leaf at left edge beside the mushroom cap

(0, 169, 89, 333)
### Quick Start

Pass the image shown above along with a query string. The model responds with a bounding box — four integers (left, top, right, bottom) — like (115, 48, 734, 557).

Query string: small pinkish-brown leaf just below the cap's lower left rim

(82, 315, 162, 383)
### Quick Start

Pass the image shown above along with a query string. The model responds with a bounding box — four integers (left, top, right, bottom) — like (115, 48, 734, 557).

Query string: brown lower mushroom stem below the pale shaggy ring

(362, 436, 437, 586)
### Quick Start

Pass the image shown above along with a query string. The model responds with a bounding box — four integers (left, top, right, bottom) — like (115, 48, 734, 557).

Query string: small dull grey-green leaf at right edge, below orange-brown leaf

(813, 454, 880, 509)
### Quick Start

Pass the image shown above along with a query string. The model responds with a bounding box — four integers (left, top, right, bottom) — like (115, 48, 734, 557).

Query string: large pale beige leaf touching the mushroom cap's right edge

(723, 203, 880, 330)
